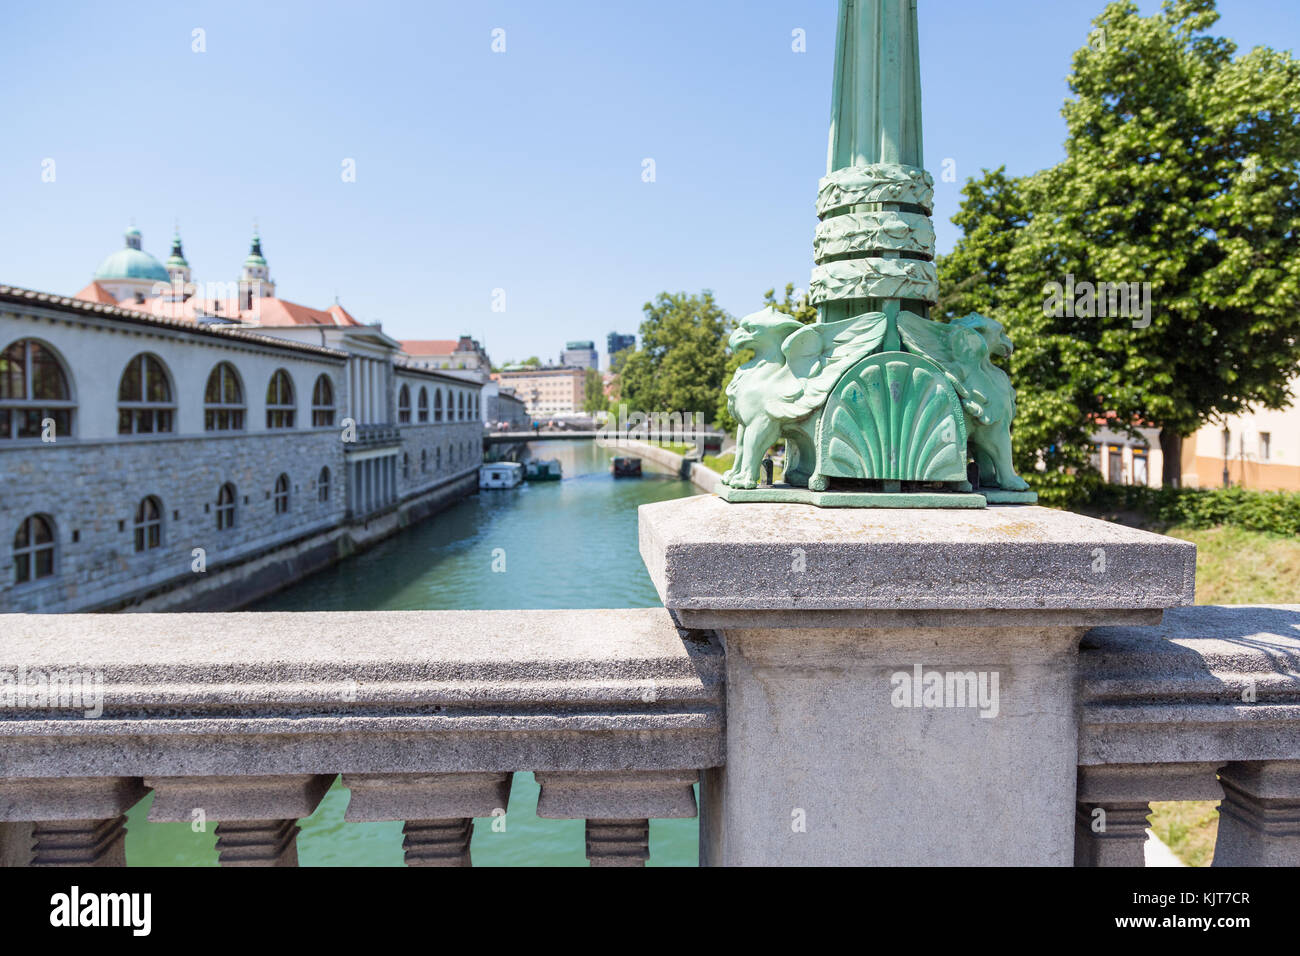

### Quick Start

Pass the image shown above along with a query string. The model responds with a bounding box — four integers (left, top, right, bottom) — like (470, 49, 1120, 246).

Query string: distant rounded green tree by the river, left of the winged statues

(619, 290, 732, 419)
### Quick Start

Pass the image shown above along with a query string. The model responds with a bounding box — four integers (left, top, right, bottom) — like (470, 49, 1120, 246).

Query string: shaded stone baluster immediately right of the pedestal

(1074, 763, 1222, 866)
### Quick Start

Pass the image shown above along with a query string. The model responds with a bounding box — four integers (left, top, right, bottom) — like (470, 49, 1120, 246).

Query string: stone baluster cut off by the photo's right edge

(1213, 760, 1300, 866)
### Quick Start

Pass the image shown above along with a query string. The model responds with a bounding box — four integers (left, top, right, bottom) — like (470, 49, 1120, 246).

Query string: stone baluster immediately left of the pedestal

(536, 770, 699, 866)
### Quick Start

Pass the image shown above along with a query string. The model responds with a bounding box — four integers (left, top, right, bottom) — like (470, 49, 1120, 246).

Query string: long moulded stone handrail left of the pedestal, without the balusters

(0, 607, 723, 777)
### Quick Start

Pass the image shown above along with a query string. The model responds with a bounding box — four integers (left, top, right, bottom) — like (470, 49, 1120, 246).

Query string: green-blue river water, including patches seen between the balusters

(126, 441, 698, 866)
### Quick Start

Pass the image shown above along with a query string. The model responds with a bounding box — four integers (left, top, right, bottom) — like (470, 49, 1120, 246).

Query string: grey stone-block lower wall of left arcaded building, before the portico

(0, 428, 346, 611)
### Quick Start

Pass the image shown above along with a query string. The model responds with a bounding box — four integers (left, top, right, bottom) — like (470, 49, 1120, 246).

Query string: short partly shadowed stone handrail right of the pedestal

(1079, 605, 1300, 766)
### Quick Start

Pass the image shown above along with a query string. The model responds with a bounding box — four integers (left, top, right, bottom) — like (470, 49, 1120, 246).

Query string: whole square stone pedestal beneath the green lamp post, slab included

(641, 497, 1195, 866)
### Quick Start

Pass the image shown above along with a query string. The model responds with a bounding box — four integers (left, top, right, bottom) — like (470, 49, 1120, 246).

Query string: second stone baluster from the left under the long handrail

(144, 774, 334, 866)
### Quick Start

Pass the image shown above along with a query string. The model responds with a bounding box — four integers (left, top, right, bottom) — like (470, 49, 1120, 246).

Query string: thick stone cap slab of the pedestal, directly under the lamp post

(640, 496, 1196, 627)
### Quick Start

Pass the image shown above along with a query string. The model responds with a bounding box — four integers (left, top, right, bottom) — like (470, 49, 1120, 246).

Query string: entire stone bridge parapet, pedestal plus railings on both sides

(0, 496, 1300, 866)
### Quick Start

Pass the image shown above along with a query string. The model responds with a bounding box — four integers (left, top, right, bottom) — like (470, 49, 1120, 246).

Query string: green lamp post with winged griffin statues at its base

(719, 0, 1036, 507)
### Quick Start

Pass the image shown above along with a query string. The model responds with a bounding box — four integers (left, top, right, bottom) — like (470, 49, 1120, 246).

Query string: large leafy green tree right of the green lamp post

(940, 0, 1300, 501)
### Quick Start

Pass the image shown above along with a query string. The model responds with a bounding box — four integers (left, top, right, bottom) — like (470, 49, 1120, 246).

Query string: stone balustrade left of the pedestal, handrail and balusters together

(0, 609, 723, 866)
